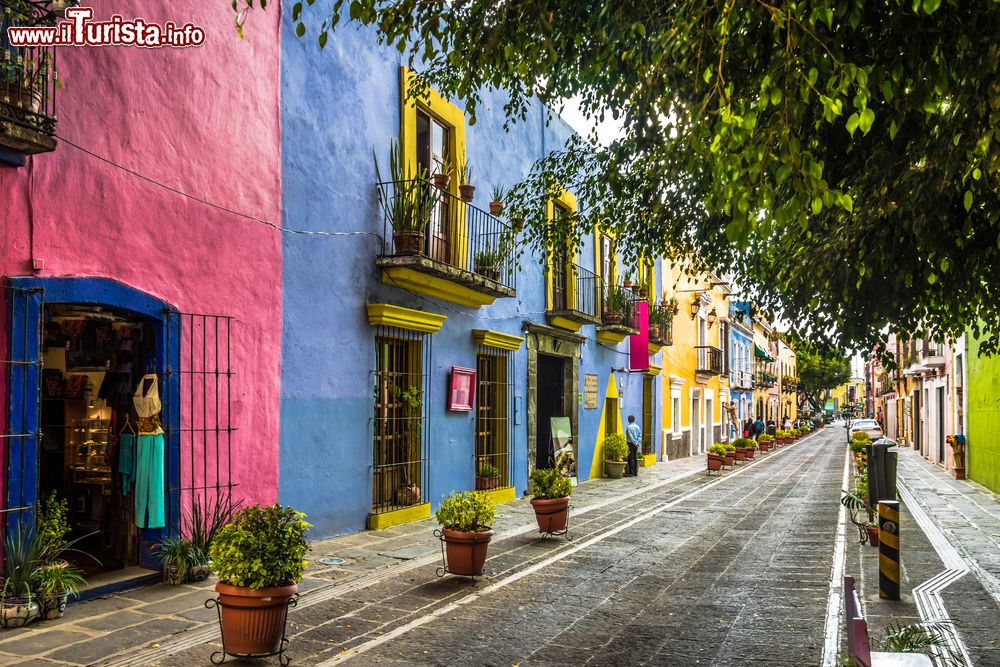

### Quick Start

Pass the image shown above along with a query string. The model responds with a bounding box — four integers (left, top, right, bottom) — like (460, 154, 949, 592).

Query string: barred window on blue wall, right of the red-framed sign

(476, 346, 514, 490)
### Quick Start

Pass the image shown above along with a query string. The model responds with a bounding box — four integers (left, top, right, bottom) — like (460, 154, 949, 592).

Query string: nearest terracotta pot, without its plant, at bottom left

(215, 581, 299, 655)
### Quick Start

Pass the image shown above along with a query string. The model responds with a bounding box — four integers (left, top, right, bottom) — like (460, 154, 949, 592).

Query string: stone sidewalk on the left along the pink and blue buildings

(0, 456, 705, 666)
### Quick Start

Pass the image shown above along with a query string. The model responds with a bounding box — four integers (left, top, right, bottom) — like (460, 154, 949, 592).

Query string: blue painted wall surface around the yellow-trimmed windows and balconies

(279, 15, 662, 537)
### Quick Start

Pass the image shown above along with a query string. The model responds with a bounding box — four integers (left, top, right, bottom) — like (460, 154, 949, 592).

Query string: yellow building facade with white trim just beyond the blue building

(658, 266, 730, 459)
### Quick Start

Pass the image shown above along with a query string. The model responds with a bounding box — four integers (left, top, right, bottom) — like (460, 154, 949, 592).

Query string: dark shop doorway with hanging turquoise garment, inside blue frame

(38, 304, 165, 576)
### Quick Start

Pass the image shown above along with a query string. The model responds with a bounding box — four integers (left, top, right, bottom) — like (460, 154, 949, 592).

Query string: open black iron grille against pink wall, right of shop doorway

(163, 311, 237, 532)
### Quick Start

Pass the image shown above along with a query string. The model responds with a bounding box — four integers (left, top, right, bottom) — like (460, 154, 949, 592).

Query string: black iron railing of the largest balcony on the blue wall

(377, 180, 517, 290)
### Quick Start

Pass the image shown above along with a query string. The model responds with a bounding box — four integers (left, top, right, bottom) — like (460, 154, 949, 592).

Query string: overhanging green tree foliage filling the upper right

(260, 0, 1000, 350)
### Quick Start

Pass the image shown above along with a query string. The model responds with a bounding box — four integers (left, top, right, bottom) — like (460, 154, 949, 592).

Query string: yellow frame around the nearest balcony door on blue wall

(399, 67, 469, 266)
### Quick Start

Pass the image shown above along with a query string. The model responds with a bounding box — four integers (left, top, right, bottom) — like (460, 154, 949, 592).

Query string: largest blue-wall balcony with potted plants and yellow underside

(375, 180, 517, 308)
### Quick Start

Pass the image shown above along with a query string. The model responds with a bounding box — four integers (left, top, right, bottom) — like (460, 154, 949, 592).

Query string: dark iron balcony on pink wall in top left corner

(0, 0, 56, 165)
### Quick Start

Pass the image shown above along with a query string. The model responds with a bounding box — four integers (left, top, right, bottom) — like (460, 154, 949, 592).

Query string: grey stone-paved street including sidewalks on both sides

(0, 427, 1000, 667)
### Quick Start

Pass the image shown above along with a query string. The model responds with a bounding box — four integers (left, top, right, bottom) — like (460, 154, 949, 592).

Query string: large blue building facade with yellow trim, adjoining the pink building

(279, 16, 669, 537)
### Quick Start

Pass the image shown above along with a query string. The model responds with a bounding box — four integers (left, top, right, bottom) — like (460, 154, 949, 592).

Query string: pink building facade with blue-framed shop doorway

(0, 0, 281, 580)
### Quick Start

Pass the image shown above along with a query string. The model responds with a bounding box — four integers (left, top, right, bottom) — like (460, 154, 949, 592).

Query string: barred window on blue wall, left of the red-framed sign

(372, 327, 431, 514)
